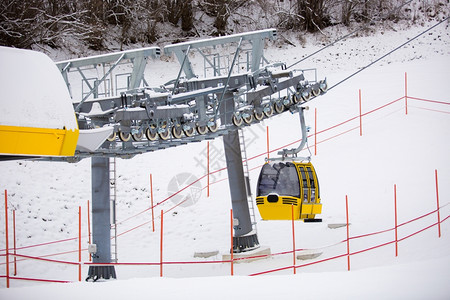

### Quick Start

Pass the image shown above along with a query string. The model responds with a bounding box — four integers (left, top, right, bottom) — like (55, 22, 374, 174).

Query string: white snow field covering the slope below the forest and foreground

(0, 23, 450, 299)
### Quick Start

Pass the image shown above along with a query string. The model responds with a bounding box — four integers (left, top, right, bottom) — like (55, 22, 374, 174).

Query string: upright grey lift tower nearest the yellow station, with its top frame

(57, 47, 160, 281)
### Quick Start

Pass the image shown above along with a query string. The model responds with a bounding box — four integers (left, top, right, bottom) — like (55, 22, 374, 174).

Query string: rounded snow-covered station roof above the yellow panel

(0, 47, 78, 130)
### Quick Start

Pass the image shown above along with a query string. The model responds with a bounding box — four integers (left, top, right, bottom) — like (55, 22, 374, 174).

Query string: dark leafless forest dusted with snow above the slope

(0, 0, 449, 51)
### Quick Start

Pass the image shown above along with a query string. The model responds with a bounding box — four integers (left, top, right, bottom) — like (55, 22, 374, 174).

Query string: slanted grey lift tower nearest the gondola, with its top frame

(164, 29, 277, 253)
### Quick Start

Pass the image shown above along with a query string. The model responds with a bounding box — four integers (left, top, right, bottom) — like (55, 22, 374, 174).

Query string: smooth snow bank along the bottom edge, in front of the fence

(0, 256, 450, 300)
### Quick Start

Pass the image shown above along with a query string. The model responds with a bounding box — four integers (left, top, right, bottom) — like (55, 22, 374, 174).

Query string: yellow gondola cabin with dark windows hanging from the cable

(256, 161, 322, 222)
